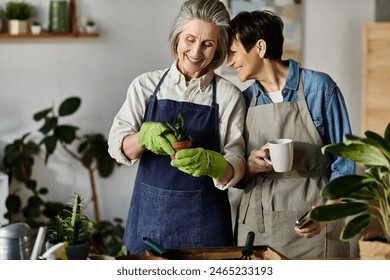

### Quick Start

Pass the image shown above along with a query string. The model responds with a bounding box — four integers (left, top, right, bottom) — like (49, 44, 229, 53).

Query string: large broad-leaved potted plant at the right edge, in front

(309, 123, 390, 258)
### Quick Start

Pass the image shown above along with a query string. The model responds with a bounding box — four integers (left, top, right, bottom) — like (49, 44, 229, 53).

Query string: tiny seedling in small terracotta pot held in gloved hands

(164, 113, 192, 159)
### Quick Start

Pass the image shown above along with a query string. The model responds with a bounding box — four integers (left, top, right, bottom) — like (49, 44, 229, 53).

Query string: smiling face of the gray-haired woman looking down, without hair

(177, 19, 219, 80)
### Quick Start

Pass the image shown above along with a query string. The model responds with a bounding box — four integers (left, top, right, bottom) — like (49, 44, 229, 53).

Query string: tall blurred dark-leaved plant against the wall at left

(3, 97, 119, 254)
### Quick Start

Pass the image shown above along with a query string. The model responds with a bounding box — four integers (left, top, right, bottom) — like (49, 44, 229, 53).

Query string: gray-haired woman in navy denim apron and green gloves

(109, 0, 245, 254)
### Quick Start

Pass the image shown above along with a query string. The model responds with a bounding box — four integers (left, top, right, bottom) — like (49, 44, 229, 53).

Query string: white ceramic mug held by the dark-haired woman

(264, 139, 294, 172)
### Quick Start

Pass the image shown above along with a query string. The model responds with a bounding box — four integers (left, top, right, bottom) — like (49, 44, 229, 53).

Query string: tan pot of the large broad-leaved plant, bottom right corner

(359, 234, 390, 260)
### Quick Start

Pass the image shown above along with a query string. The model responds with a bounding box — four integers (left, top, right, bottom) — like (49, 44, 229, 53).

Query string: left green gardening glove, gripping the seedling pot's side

(138, 122, 176, 156)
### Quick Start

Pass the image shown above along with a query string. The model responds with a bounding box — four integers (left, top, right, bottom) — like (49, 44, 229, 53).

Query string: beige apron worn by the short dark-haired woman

(237, 76, 349, 258)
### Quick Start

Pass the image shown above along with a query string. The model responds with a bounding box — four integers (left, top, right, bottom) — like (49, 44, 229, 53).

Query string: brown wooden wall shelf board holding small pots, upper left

(0, 33, 100, 40)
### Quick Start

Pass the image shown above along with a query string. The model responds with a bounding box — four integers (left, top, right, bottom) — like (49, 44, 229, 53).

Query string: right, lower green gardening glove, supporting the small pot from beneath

(171, 148, 227, 179)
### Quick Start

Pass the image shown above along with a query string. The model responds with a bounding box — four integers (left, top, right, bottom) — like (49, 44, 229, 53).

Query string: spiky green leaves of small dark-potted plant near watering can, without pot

(46, 193, 95, 245)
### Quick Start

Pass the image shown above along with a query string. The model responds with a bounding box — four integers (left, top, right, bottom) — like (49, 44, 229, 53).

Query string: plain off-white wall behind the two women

(0, 0, 375, 224)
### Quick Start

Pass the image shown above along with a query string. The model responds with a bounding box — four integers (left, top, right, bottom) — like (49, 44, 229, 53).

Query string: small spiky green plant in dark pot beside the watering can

(46, 193, 95, 260)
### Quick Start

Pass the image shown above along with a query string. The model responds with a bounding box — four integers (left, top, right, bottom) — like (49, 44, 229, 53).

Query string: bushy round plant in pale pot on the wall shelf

(4, 1, 33, 35)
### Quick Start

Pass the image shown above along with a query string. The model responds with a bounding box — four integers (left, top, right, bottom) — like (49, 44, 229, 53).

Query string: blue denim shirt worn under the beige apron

(244, 59, 355, 180)
